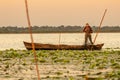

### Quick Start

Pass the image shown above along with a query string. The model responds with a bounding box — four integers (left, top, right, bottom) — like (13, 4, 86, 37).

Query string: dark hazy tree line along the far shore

(0, 25, 120, 33)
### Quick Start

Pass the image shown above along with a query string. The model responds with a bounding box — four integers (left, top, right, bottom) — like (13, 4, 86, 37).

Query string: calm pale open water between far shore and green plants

(0, 33, 120, 50)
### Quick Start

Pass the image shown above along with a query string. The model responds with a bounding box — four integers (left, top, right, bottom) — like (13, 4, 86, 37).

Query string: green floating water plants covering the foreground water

(0, 49, 120, 80)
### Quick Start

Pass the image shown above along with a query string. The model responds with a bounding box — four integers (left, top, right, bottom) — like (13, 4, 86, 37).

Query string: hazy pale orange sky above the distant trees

(0, 0, 120, 26)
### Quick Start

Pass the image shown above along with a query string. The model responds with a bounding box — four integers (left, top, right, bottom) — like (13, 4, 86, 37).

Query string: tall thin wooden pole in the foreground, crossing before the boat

(25, 0, 40, 80)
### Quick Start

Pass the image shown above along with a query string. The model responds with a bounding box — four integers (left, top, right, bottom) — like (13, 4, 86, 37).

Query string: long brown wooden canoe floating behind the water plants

(23, 41, 104, 50)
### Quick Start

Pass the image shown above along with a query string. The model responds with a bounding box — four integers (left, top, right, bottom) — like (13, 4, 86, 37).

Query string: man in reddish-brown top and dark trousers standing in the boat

(83, 23, 93, 46)
